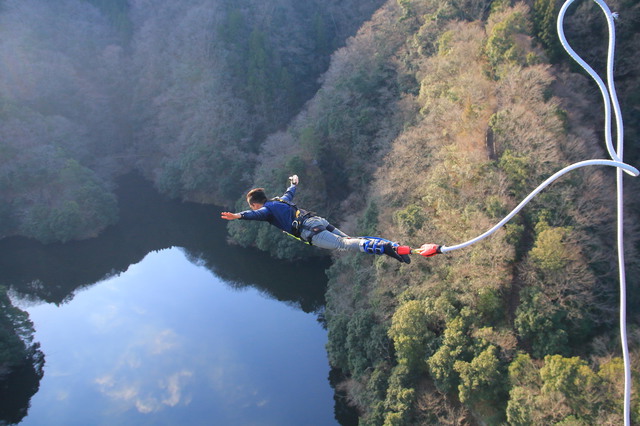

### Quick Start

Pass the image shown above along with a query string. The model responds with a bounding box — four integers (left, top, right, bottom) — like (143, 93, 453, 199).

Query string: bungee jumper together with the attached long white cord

(222, 0, 640, 420)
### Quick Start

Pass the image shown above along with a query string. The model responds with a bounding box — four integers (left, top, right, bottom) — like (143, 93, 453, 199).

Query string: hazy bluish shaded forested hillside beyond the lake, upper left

(0, 0, 381, 242)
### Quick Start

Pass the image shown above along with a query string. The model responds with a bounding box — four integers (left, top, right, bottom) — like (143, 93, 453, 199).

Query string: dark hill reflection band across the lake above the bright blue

(0, 176, 328, 312)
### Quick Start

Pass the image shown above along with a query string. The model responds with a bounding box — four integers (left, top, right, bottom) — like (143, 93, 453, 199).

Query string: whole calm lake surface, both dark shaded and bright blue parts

(0, 174, 338, 425)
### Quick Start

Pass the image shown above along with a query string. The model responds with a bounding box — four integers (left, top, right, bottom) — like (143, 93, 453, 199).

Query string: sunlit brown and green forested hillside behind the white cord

(231, 1, 640, 425)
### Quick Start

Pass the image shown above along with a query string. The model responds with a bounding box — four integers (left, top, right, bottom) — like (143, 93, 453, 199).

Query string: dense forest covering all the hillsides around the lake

(0, 0, 640, 425)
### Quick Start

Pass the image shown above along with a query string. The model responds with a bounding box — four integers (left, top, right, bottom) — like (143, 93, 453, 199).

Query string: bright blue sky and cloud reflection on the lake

(22, 248, 336, 425)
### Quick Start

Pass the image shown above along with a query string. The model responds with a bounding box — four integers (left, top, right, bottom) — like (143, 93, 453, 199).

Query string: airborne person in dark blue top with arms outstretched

(221, 175, 418, 263)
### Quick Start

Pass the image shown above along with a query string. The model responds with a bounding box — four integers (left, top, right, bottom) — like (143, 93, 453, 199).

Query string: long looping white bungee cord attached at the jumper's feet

(430, 0, 640, 426)
